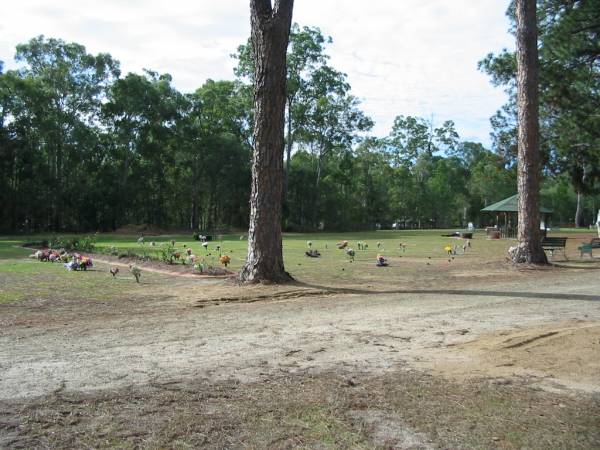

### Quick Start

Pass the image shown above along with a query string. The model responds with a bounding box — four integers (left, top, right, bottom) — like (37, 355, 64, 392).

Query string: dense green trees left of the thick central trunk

(0, 37, 250, 231)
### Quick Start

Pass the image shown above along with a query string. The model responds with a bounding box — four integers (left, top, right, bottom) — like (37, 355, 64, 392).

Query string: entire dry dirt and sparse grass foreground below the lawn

(0, 251, 600, 449)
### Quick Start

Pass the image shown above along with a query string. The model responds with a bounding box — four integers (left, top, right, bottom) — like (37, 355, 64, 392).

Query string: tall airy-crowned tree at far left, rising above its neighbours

(10, 36, 119, 230)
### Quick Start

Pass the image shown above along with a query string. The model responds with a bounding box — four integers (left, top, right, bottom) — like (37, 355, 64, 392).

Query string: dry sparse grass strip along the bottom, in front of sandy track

(0, 371, 600, 449)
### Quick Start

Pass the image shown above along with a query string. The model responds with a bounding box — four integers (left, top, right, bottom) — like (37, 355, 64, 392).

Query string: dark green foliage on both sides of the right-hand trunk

(480, 0, 600, 225)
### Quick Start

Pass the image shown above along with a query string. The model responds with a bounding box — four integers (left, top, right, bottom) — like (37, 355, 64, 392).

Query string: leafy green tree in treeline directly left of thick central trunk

(177, 80, 250, 230)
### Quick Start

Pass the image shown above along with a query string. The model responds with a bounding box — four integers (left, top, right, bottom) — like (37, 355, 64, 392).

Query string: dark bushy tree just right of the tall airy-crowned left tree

(103, 71, 181, 226)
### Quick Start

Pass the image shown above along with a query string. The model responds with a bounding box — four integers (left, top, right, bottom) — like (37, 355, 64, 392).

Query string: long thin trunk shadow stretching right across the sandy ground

(294, 281, 600, 302)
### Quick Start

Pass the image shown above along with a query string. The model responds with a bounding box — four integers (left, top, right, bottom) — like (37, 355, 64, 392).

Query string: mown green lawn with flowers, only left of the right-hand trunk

(0, 230, 513, 284)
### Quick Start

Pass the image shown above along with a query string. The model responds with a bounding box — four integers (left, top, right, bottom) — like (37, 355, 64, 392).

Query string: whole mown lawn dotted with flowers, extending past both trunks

(0, 230, 595, 301)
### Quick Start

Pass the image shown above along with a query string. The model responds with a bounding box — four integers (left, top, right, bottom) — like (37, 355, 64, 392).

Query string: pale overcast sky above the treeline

(0, 0, 514, 145)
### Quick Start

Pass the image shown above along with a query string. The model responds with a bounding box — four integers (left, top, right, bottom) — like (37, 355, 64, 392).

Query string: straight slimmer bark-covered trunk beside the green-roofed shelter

(512, 0, 547, 264)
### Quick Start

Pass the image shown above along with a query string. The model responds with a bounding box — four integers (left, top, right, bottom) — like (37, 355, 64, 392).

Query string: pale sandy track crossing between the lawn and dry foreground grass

(0, 264, 600, 400)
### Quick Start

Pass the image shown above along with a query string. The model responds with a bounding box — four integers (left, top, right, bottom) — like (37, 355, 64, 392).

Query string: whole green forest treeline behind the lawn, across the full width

(0, 0, 600, 232)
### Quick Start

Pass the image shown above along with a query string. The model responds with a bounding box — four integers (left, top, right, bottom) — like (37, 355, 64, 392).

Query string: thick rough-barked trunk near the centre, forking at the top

(240, 0, 294, 282)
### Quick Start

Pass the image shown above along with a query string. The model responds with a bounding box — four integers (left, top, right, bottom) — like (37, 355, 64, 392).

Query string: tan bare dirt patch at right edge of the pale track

(428, 320, 600, 392)
